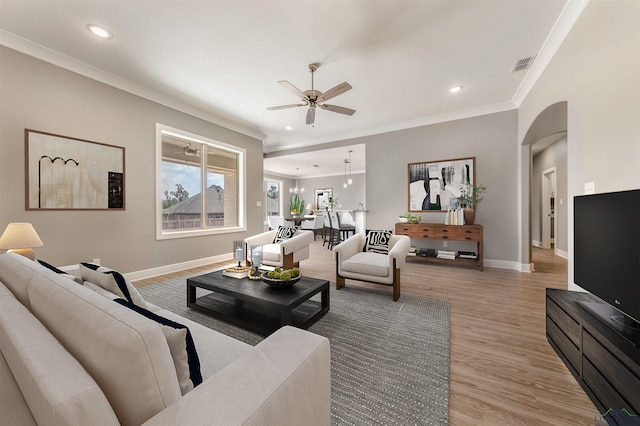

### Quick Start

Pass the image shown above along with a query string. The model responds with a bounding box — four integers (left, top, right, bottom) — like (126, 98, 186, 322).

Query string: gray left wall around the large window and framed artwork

(0, 46, 262, 272)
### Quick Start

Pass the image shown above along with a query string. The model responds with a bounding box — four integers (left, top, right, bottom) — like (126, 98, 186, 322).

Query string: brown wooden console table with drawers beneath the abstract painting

(395, 223, 484, 271)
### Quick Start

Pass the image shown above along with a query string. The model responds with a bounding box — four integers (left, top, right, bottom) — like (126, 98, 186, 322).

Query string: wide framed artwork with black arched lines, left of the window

(25, 129, 125, 210)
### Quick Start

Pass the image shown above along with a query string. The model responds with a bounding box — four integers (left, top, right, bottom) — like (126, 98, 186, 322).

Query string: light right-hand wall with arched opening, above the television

(518, 0, 640, 288)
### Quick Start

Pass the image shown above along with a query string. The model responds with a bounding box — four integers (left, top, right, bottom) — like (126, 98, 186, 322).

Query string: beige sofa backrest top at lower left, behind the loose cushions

(0, 282, 119, 425)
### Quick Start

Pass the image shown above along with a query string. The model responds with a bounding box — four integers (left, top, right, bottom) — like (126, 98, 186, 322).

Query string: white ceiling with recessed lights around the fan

(0, 0, 587, 177)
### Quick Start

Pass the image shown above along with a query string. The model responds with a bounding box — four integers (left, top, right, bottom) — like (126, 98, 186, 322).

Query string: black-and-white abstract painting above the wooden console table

(408, 157, 476, 212)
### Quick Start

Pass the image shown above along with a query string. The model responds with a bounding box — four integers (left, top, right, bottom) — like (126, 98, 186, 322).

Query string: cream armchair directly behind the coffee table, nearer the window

(244, 229, 313, 269)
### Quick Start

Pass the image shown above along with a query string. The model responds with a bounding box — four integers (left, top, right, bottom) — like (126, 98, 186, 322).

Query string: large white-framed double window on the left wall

(156, 124, 246, 239)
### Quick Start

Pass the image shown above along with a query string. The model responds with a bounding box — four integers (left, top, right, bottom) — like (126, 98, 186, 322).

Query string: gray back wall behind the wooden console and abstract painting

(284, 110, 518, 269)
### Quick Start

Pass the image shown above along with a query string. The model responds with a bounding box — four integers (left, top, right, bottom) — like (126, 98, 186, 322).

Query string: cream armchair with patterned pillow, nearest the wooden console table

(333, 231, 411, 301)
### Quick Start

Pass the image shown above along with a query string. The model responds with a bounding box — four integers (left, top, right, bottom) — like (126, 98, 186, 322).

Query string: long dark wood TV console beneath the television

(546, 288, 640, 415)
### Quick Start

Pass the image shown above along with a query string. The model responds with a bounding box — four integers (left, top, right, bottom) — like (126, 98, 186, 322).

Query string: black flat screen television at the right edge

(573, 189, 640, 346)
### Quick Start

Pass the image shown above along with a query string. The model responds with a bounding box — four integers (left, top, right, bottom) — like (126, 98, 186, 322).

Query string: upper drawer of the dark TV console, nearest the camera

(582, 331, 640, 413)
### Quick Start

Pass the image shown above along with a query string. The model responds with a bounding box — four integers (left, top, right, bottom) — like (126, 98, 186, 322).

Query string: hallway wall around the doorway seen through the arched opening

(531, 139, 570, 252)
